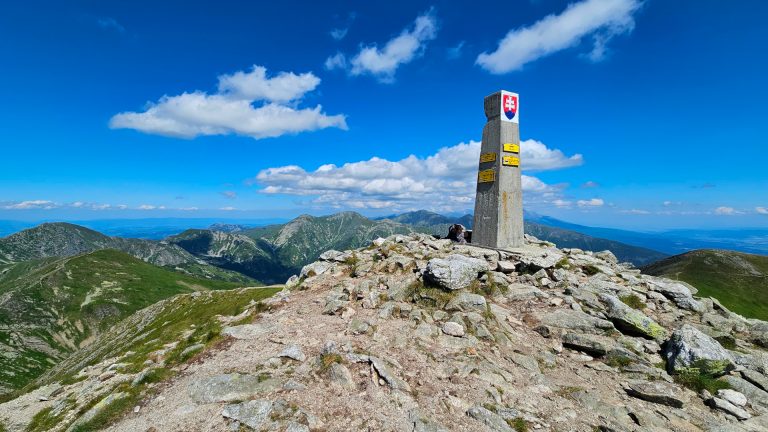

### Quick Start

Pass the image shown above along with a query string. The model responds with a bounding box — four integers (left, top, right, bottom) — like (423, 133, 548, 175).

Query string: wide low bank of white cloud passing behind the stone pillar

(255, 140, 581, 210)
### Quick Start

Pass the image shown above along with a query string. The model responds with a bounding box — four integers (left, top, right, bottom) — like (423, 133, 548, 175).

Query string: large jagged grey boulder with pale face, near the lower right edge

(665, 324, 734, 375)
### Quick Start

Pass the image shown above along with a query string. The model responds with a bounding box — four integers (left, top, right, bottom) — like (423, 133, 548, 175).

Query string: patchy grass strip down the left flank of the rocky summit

(25, 286, 282, 432)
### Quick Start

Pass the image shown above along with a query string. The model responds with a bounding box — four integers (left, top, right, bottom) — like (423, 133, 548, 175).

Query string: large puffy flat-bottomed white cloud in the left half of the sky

(109, 66, 347, 139)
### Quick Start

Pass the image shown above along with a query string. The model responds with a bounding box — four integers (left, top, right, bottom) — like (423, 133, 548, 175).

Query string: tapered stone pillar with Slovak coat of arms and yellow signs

(472, 90, 523, 249)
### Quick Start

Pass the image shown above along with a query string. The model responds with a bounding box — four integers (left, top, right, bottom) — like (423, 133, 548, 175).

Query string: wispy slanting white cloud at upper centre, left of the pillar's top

(325, 11, 437, 82)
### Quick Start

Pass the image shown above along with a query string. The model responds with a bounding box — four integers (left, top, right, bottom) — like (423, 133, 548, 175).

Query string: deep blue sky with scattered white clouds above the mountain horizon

(0, 0, 768, 230)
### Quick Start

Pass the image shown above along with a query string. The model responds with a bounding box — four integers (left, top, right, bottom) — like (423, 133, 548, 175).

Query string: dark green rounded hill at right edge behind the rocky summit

(643, 249, 768, 321)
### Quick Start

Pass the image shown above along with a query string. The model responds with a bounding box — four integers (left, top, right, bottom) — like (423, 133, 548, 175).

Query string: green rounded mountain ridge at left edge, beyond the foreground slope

(0, 250, 248, 389)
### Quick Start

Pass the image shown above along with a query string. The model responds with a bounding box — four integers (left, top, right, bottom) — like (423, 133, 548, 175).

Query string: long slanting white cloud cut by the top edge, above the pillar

(476, 0, 642, 74)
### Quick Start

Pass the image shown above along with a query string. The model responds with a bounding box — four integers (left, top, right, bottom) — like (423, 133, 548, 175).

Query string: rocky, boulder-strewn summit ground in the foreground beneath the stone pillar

(0, 234, 768, 432)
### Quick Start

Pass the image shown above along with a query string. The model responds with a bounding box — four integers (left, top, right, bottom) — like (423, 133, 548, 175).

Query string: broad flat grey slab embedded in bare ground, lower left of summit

(188, 373, 280, 403)
